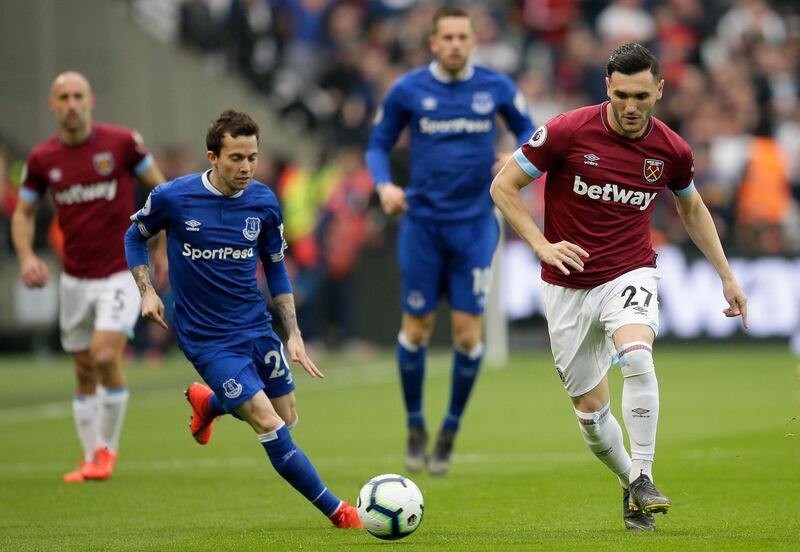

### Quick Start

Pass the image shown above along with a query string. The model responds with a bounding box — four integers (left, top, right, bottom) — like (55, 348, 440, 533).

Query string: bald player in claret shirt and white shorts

(12, 71, 164, 482)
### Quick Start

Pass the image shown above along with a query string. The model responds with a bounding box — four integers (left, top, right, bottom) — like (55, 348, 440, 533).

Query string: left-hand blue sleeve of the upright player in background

(365, 83, 411, 186)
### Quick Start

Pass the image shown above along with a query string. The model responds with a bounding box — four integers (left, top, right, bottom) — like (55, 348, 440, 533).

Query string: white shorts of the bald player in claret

(59, 271, 142, 353)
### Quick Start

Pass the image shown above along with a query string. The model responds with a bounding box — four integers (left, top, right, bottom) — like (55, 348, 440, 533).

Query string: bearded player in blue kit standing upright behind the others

(366, 6, 533, 475)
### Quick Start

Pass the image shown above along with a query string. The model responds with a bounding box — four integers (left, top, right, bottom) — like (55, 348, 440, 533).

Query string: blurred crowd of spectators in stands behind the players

(0, 0, 800, 354)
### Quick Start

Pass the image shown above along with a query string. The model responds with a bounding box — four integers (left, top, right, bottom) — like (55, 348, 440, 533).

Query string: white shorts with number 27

(542, 268, 661, 397)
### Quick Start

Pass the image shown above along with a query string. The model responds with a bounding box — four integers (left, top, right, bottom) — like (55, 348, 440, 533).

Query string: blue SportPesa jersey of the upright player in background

(366, 63, 533, 220)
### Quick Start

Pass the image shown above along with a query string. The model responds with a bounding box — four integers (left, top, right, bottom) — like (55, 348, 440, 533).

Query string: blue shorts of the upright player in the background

(397, 213, 500, 316)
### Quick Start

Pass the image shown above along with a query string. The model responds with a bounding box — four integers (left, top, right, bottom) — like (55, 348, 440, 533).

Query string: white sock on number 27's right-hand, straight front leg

(622, 371, 658, 481)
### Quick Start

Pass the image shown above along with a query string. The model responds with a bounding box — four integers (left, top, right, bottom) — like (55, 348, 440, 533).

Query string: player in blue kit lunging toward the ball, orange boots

(125, 110, 361, 528)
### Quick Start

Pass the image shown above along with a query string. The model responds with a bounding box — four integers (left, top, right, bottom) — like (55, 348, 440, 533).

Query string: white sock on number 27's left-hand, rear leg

(575, 403, 631, 488)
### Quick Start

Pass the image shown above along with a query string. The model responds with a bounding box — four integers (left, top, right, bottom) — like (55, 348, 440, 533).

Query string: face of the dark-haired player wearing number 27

(606, 70, 664, 138)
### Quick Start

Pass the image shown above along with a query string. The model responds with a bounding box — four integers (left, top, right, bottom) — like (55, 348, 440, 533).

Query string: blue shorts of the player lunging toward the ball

(186, 332, 294, 412)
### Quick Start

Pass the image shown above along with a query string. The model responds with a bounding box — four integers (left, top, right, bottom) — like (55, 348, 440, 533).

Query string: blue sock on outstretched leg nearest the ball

(258, 424, 341, 516)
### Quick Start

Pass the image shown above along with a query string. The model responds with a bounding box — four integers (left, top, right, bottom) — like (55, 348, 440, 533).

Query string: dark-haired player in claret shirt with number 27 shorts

(491, 44, 747, 531)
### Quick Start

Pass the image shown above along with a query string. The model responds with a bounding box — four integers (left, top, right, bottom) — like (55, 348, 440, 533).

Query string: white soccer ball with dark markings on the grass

(356, 473, 425, 540)
